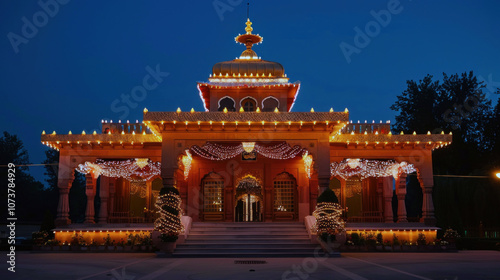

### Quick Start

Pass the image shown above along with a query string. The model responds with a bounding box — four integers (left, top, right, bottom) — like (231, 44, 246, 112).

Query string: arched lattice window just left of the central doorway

(201, 172, 224, 213)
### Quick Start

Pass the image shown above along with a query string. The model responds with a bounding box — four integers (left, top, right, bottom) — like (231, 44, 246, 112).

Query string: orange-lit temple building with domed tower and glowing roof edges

(41, 20, 452, 244)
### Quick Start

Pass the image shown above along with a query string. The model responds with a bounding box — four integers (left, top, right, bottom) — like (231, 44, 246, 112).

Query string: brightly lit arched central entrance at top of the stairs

(234, 176, 263, 222)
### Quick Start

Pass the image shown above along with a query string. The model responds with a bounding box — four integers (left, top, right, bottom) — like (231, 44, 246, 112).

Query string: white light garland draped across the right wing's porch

(330, 159, 417, 179)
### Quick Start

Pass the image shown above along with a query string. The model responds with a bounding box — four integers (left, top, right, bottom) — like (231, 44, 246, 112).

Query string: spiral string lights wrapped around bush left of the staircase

(154, 193, 184, 235)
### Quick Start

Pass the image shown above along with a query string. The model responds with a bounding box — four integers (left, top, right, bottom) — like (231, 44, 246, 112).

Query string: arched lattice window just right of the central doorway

(273, 172, 297, 212)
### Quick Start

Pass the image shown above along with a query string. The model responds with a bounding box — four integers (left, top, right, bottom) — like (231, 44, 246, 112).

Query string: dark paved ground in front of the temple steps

(0, 251, 500, 280)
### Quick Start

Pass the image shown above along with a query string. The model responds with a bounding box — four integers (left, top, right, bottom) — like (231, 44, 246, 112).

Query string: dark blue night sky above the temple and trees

(0, 0, 500, 185)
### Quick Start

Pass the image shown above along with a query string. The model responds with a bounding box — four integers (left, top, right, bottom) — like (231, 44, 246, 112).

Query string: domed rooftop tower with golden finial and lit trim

(198, 19, 300, 112)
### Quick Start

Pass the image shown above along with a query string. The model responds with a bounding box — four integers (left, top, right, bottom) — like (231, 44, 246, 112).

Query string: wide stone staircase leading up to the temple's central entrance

(173, 222, 318, 258)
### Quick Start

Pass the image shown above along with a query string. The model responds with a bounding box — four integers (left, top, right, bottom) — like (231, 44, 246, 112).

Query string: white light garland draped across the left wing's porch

(76, 159, 161, 181)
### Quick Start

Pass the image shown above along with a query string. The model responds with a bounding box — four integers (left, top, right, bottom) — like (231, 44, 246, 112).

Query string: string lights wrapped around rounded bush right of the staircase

(311, 202, 345, 235)
